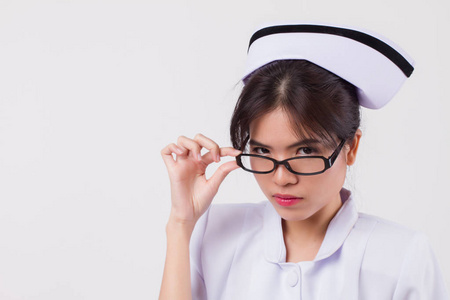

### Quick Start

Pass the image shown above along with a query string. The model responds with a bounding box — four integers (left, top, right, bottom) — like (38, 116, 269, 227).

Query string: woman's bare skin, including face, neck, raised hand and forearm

(159, 109, 361, 300)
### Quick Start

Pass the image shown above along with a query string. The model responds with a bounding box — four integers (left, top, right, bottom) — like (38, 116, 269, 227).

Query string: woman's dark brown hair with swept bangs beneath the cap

(230, 60, 361, 150)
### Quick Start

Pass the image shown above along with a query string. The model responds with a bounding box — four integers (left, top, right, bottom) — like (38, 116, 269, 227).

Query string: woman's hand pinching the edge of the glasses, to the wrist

(161, 134, 240, 225)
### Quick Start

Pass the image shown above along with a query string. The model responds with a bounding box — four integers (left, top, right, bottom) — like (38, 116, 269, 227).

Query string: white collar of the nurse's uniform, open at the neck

(264, 189, 358, 263)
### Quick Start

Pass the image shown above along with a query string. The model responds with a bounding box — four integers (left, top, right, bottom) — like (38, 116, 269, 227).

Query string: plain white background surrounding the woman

(0, 0, 450, 300)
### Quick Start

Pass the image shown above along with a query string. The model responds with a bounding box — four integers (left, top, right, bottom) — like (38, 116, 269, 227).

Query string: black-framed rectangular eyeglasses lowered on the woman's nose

(236, 140, 345, 175)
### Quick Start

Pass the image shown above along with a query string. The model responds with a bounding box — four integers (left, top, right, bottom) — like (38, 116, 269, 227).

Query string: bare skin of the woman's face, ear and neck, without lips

(250, 109, 361, 262)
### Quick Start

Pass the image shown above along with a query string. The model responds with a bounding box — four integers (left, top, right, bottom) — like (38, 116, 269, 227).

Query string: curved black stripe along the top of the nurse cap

(248, 24, 414, 77)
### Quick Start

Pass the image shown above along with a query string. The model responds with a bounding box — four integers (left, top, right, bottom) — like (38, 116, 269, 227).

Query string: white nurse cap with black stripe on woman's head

(243, 24, 414, 109)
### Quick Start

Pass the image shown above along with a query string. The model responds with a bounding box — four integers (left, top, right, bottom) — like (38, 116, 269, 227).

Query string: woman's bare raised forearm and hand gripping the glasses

(159, 135, 240, 300)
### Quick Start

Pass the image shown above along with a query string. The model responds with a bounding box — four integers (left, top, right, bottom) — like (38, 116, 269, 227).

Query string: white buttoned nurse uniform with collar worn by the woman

(191, 190, 449, 300)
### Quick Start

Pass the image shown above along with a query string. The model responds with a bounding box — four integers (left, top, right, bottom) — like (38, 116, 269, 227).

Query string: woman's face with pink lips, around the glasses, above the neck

(249, 109, 352, 221)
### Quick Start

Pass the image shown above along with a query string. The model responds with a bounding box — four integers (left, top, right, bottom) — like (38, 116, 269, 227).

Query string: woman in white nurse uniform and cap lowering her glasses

(160, 24, 449, 300)
